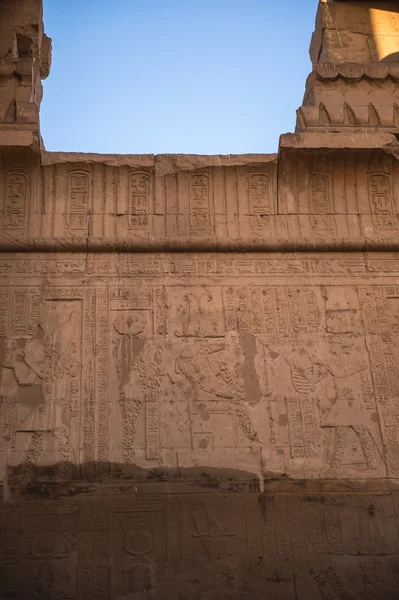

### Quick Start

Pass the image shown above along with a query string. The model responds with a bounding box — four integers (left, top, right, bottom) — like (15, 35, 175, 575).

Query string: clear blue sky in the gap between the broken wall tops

(41, 0, 317, 154)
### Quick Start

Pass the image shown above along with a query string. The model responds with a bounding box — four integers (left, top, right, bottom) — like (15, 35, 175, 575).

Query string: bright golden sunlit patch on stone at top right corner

(369, 2, 399, 62)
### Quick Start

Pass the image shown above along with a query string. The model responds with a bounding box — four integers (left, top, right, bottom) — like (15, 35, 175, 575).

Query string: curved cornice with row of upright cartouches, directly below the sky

(0, 150, 399, 249)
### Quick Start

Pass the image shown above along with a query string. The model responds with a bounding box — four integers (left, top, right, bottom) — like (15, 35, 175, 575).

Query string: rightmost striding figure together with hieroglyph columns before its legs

(266, 335, 381, 475)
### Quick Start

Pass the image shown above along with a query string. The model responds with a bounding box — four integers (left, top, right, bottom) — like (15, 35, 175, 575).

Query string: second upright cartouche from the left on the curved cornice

(66, 171, 90, 231)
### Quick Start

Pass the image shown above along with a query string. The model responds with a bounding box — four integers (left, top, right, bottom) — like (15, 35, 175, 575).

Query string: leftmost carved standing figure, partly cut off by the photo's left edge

(2, 303, 81, 476)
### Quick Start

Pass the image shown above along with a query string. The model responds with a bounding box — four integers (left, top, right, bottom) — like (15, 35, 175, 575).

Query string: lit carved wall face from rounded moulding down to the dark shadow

(0, 253, 399, 486)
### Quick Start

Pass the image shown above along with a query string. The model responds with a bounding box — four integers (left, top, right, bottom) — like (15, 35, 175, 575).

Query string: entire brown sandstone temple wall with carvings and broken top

(0, 0, 399, 600)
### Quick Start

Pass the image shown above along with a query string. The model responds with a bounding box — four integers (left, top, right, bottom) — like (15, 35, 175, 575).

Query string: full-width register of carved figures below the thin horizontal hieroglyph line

(1, 282, 399, 478)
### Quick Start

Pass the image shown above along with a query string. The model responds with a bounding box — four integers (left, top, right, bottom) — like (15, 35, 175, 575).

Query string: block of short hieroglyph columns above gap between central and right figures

(223, 287, 321, 335)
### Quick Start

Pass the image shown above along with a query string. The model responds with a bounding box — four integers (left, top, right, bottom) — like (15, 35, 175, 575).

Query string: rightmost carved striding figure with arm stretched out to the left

(265, 335, 378, 474)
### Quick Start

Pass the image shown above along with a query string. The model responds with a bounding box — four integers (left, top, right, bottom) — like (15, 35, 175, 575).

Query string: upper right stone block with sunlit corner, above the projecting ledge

(297, 2, 399, 133)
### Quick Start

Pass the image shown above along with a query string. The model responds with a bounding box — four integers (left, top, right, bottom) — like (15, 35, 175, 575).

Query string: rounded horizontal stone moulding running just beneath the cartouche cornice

(0, 237, 399, 253)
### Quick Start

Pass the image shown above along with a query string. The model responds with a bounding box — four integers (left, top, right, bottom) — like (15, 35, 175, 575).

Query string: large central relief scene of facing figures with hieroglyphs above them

(106, 286, 385, 476)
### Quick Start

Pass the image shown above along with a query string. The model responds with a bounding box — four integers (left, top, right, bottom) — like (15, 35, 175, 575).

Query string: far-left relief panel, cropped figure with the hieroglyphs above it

(1, 289, 81, 477)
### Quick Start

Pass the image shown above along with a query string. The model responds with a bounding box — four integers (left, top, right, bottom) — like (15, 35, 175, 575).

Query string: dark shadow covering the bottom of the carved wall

(0, 464, 399, 600)
